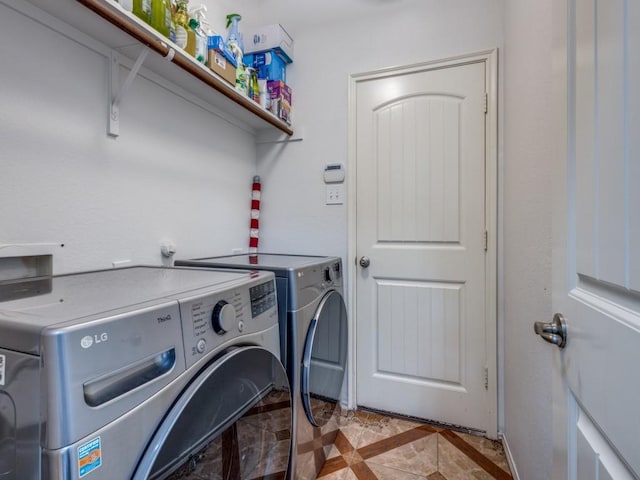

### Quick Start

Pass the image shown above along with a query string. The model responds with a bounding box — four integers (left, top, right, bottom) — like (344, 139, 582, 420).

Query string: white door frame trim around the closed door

(345, 49, 498, 438)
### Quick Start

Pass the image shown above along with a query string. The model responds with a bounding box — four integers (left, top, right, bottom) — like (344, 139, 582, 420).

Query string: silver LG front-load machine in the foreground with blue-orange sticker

(0, 267, 292, 480)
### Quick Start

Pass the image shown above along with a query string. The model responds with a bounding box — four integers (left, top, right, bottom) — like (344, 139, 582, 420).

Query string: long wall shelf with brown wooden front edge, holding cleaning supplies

(20, 0, 293, 136)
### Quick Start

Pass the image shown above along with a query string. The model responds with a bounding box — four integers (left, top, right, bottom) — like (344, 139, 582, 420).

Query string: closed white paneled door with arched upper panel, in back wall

(354, 54, 495, 432)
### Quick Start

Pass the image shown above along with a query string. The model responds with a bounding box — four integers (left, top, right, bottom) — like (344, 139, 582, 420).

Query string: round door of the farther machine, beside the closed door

(301, 290, 347, 427)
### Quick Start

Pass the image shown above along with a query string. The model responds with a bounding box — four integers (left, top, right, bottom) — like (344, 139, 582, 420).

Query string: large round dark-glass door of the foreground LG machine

(133, 347, 292, 480)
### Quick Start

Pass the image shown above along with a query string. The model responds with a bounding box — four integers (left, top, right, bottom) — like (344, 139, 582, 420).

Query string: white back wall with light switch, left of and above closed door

(250, 1, 503, 420)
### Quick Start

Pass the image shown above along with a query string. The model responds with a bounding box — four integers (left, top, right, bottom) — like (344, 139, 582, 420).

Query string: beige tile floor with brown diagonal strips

(318, 411, 512, 480)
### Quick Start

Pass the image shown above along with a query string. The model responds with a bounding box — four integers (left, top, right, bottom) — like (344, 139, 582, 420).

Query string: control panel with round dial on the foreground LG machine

(180, 272, 278, 368)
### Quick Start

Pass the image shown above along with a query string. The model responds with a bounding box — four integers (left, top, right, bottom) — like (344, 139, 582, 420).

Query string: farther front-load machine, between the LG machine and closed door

(176, 253, 348, 480)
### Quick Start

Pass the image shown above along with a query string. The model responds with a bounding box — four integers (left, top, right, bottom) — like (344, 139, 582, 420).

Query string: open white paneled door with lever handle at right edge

(549, 0, 640, 480)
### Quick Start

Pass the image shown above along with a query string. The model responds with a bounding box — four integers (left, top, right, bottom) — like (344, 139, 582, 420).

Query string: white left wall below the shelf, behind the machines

(0, 2, 255, 273)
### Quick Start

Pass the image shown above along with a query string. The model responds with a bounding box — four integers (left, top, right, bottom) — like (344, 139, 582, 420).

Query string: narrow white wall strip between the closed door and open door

(503, 0, 553, 480)
